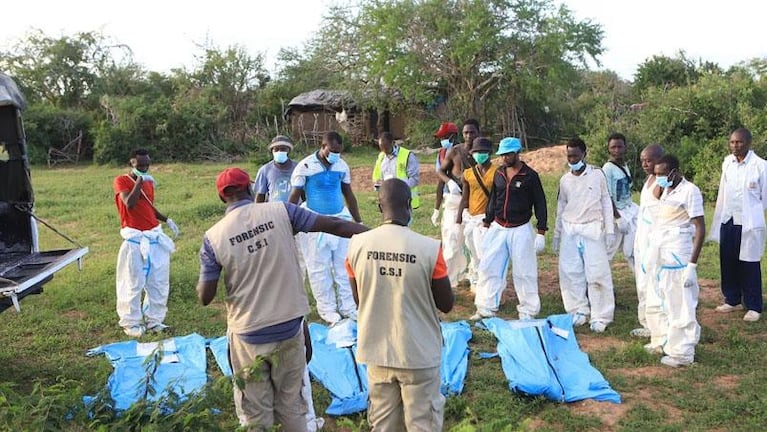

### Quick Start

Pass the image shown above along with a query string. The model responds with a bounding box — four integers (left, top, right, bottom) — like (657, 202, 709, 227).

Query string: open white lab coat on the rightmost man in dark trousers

(708, 150, 767, 262)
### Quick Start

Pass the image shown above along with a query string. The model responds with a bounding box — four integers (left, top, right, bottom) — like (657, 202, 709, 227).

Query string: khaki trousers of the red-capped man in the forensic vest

(228, 328, 307, 432)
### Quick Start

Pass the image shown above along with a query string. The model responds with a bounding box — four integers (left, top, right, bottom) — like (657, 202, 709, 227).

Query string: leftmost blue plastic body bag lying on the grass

(83, 333, 207, 411)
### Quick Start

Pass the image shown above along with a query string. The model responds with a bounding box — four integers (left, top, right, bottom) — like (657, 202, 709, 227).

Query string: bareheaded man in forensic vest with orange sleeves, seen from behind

(347, 179, 453, 432)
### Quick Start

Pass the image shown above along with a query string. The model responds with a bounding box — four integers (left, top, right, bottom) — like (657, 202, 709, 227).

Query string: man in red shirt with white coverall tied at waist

(112, 149, 178, 337)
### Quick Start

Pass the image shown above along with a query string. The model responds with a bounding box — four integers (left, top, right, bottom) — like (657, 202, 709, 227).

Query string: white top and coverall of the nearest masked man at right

(645, 180, 703, 363)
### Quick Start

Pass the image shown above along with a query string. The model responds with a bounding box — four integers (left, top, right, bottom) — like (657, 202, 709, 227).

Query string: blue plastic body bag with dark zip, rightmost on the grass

(482, 314, 621, 403)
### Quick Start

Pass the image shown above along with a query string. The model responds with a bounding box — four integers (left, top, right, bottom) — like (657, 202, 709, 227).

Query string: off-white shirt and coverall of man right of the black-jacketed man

(554, 165, 615, 325)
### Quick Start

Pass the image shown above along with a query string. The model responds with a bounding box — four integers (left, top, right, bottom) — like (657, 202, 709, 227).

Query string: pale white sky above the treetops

(0, 0, 767, 80)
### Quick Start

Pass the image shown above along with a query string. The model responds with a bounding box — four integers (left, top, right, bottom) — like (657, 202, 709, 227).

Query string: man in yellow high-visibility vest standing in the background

(373, 132, 421, 209)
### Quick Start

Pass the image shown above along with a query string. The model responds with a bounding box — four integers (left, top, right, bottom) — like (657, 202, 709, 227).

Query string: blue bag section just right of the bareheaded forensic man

(439, 321, 471, 396)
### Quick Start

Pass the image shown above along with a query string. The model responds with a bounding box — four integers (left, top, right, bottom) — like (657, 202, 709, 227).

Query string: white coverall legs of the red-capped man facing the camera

(441, 193, 467, 288)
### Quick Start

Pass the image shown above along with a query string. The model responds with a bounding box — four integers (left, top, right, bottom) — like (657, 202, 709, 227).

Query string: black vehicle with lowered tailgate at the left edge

(0, 72, 88, 312)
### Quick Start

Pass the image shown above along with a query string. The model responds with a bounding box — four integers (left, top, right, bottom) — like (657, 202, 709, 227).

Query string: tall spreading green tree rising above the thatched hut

(318, 0, 602, 134)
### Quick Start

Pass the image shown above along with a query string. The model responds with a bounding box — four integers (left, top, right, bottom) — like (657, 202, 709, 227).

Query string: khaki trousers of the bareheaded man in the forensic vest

(367, 365, 445, 432)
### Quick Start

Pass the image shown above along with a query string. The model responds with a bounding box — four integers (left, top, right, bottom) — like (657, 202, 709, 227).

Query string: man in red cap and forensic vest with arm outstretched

(197, 168, 367, 431)
